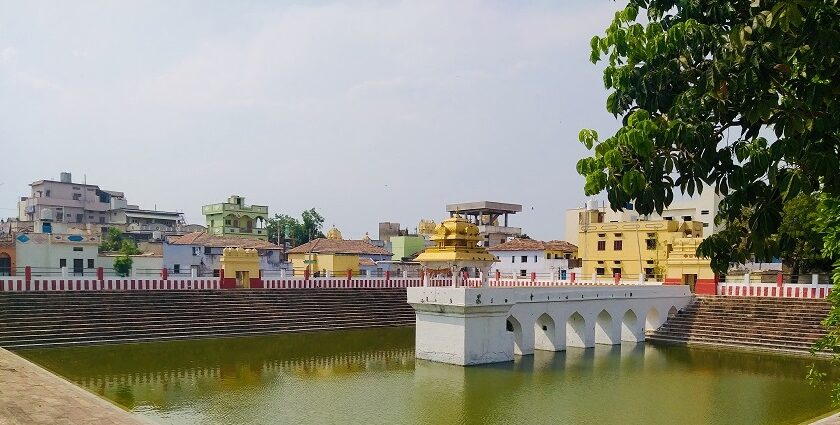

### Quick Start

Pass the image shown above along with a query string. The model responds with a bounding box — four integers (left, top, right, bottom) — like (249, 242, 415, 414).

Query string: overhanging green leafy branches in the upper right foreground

(577, 0, 840, 272)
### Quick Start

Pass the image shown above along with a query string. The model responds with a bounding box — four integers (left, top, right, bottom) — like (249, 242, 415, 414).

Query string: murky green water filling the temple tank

(20, 328, 831, 424)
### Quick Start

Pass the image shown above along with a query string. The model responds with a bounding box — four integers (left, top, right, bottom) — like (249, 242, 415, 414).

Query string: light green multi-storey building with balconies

(201, 195, 268, 241)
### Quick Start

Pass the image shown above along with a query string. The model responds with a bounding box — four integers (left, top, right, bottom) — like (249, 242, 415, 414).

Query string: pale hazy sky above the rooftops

(0, 0, 621, 240)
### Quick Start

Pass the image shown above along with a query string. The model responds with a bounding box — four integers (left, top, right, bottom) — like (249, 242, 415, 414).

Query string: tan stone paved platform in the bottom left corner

(0, 348, 153, 425)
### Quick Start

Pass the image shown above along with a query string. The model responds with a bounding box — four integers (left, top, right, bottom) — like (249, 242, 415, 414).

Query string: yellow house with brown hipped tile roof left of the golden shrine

(288, 238, 393, 276)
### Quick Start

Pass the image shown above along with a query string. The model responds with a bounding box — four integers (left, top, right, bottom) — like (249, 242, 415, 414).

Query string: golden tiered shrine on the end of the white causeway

(416, 214, 499, 288)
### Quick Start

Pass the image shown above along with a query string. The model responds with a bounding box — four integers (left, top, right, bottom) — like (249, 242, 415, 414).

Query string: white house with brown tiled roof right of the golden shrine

(487, 238, 578, 279)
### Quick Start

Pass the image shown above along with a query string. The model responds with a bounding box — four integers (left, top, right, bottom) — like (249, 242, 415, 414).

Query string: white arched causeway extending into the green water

(408, 285, 692, 365)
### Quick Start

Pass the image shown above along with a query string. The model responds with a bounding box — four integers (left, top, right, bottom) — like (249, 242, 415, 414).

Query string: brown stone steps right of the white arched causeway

(647, 297, 830, 354)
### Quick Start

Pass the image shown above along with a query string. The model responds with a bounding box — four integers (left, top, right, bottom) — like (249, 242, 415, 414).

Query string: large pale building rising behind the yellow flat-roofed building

(565, 186, 721, 244)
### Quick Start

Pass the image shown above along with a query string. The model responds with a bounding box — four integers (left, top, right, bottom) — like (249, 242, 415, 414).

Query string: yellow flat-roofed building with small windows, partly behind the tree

(578, 207, 711, 279)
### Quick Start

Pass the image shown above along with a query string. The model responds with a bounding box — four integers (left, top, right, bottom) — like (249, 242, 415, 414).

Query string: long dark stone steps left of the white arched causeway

(0, 288, 415, 348)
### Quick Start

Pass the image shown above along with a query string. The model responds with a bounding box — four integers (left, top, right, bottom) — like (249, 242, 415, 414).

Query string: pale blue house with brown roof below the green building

(163, 232, 286, 276)
